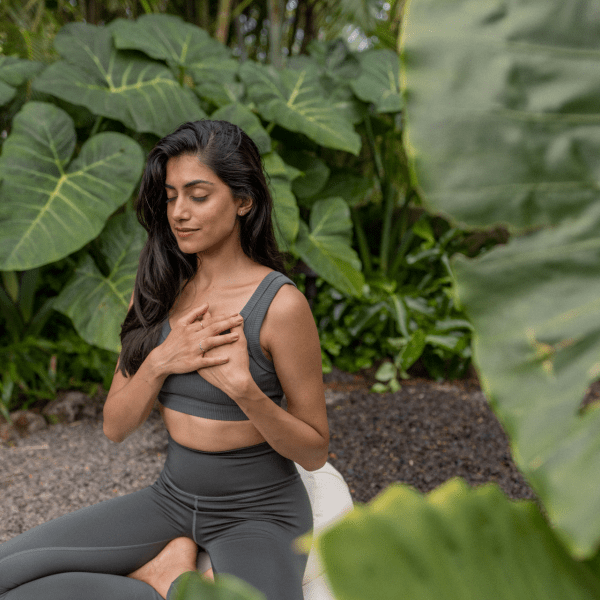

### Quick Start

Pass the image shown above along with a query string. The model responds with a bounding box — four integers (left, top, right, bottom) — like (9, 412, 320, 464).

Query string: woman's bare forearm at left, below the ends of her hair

(103, 353, 167, 442)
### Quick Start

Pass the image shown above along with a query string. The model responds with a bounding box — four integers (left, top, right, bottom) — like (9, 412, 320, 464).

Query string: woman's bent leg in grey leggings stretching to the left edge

(0, 487, 191, 600)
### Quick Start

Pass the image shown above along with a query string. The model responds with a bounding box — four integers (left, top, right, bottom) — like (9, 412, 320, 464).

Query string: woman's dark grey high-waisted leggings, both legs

(0, 438, 312, 600)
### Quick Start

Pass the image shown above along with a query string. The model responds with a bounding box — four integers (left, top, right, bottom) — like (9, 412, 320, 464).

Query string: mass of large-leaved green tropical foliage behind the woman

(0, 4, 469, 410)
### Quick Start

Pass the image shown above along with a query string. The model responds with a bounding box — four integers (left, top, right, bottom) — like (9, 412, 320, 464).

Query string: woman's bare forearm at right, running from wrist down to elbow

(233, 381, 329, 471)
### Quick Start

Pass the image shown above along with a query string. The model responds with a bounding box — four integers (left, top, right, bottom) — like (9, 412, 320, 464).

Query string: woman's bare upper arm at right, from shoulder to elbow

(261, 285, 329, 440)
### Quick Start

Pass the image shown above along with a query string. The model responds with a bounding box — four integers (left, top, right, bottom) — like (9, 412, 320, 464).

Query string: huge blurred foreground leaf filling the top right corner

(403, 0, 600, 229)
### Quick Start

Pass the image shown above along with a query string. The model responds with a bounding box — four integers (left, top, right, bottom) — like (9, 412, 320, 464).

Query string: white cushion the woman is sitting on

(198, 463, 352, 600)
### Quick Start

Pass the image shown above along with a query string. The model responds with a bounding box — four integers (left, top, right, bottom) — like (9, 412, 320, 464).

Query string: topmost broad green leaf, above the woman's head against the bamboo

(113, 14, 238, 83)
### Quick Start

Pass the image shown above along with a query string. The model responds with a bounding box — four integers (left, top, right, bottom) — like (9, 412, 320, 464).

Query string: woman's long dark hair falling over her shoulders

(119, 120, 285, 376)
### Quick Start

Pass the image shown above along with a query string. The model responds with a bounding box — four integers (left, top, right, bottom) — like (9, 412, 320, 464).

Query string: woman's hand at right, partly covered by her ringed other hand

(198, 323, 252, 399)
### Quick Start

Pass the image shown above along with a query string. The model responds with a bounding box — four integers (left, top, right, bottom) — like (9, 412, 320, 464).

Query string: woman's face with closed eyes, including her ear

(165, 156, 251, 254)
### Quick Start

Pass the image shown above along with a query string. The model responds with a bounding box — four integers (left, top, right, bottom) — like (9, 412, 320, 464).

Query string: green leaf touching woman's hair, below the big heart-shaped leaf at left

(54, 212, 146, 352)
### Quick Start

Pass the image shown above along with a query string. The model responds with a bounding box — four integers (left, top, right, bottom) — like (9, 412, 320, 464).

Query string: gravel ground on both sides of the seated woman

(0, 373, 534, 542)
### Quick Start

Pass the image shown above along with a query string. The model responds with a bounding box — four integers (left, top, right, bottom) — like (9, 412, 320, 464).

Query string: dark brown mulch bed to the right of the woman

(328, 380, 535, 502)
